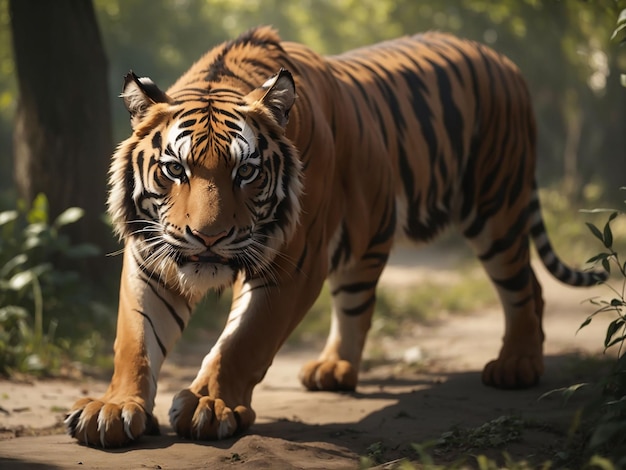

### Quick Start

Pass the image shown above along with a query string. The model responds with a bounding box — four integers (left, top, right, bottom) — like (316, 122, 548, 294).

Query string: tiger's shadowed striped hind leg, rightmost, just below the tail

(470, 224, 544, 389)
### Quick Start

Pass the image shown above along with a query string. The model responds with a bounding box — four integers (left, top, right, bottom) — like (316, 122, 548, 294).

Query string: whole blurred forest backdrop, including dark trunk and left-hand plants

(0, 0, 626, 373)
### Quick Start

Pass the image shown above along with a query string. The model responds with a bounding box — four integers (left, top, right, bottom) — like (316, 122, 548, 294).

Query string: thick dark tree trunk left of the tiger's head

(9, 0, 112, 255)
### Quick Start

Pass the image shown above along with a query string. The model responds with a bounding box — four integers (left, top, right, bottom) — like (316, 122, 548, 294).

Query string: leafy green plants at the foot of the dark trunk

(0, 195, 111, 375)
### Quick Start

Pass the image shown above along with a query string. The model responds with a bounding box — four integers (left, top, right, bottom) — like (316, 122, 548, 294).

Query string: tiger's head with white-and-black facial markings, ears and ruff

(108, 69, 302, 296)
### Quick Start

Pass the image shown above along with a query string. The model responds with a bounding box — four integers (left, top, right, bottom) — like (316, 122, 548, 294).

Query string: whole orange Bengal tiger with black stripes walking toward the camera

(65, 27, 602, 447)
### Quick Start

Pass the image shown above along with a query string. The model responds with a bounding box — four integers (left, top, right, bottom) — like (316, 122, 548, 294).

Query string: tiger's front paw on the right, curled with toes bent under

(170, 389, 256, 440)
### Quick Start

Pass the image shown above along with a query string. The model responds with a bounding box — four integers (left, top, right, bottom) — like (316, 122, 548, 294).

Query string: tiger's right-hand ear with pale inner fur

(246, 68, 296, 129)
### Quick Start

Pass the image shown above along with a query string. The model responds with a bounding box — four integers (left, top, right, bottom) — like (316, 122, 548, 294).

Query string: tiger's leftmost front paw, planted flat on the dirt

(65, 398, 159, 448)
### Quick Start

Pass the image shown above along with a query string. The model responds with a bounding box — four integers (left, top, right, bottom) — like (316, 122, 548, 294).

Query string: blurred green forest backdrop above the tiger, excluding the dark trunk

(0, 0, 626, 204)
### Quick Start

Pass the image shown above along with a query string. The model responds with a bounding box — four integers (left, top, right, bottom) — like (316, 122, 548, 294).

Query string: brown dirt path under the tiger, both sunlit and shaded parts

(0, 250, 609, 469)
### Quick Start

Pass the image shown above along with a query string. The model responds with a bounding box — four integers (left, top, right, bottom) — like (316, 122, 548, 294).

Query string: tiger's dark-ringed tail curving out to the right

(529, 188, 609, 287)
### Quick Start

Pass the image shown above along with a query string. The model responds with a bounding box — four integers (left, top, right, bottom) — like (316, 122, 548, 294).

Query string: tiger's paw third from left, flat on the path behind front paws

(299, 360, 359, 391)
